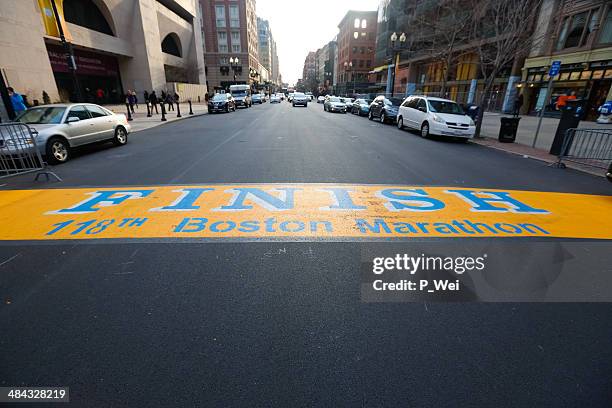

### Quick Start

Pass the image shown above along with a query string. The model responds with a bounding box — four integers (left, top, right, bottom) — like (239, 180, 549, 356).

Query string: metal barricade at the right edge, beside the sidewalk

(557, 129, 612, 169)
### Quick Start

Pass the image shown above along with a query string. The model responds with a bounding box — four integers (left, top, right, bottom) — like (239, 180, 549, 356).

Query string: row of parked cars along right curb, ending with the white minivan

(317, 95, 476, 140)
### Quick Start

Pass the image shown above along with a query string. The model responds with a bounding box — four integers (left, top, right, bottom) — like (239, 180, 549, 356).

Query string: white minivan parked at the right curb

(397, 96, 476, 140)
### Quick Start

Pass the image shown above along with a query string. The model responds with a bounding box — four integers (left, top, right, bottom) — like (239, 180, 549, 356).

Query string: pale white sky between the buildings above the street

(256, 0, 379, 85)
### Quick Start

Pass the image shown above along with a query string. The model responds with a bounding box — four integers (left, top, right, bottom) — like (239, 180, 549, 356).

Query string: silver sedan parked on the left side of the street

(12, 103, 131, 164)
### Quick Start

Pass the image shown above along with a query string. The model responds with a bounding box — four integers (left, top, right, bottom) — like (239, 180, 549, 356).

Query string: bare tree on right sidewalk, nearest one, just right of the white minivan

(470, 0, 542, 136)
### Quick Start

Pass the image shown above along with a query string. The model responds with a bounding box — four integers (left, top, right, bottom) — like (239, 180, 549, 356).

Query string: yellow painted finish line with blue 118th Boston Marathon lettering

(0, 184, 612, 240)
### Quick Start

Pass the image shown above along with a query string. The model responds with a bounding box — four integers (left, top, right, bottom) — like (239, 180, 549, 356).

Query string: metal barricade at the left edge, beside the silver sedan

(0, 123, 61, 181)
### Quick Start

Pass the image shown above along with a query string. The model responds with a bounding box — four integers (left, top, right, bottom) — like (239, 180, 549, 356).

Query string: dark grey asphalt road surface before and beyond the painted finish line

(0, 103, 612, 407)
